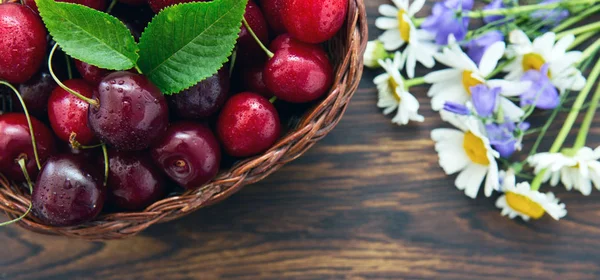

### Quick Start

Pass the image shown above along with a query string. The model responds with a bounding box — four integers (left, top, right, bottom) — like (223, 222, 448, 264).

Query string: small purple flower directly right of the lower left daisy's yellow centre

(485, 120, 529, 158)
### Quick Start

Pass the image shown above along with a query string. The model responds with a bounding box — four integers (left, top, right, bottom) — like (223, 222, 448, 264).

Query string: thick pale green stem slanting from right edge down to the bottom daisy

(531, 58, 600, 191)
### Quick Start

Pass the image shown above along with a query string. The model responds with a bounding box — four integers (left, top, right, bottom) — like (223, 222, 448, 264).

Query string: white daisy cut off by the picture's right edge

(527, 147, 600, 195)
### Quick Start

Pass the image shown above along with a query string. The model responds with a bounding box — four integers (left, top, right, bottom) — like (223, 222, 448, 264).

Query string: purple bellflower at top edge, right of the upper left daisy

(421, 0, 473, 45)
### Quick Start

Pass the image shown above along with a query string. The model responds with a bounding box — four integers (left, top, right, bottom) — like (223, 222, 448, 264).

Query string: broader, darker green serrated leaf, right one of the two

(138, 0, 248, 94)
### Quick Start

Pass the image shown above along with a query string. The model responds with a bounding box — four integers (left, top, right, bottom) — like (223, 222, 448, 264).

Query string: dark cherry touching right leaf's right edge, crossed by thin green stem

(237, 0, 269, 64)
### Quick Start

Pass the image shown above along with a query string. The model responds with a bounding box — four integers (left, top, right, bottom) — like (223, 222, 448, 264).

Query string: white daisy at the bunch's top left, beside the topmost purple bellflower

(375, 0, 437, 78)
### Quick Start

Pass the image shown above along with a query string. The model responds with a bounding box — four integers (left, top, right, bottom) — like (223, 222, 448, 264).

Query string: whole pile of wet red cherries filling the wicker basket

(0, 0, 348, 226)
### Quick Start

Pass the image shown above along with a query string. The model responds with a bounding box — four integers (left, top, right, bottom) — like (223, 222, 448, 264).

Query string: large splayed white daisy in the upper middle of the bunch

(424, 36, 531, 121)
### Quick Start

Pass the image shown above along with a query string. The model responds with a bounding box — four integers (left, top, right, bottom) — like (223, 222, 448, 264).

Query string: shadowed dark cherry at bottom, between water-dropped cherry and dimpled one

(107, 150, 165, 211)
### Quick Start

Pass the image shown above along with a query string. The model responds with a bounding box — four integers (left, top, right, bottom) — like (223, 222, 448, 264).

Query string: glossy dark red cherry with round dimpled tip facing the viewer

(152, 122, 221, 189)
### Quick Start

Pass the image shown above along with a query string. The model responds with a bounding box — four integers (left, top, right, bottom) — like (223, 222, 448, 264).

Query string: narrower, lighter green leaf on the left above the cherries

(36, 0, 139, 70)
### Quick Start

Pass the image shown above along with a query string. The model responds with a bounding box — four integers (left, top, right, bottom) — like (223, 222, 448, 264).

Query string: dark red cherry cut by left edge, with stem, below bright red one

(0, 113, 55, 181)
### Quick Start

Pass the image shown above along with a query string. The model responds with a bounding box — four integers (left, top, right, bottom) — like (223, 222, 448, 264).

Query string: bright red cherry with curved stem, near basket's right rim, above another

(263, 36, 333, 103)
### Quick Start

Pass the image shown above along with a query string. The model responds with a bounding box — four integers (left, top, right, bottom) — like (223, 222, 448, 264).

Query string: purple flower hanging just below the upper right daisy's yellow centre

(521, 64, 560, 110)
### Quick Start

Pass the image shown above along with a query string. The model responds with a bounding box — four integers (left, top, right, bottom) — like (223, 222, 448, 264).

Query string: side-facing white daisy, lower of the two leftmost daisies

(373, 52, 424, 125)
